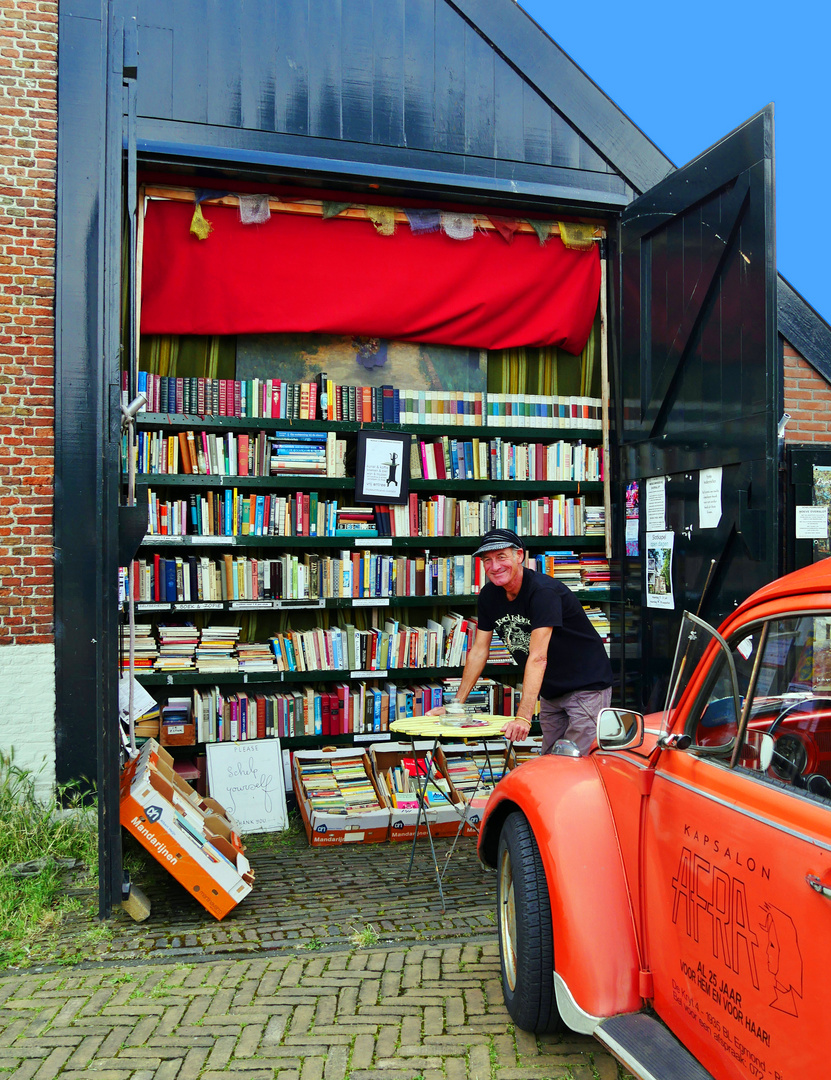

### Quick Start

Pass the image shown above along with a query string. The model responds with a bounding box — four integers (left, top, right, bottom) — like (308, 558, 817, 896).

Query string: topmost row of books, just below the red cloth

(137, 372, 602, 430)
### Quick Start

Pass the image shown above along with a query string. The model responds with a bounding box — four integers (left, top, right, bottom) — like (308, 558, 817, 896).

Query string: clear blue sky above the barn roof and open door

(520, 0, 831, 322)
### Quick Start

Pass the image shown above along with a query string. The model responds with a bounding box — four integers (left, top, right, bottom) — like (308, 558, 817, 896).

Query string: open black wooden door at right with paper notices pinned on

(617, 106, 781, 708)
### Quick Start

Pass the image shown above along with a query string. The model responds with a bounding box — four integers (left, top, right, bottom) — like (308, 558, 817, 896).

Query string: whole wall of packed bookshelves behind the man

(123, 339, 613, 754)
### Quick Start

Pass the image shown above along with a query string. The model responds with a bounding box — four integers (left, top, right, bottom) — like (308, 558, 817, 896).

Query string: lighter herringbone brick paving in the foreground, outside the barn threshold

(0, 942, 618, 1080)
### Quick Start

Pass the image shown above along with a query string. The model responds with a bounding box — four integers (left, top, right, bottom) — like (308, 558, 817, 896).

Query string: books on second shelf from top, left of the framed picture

(131, 431, 346, 476)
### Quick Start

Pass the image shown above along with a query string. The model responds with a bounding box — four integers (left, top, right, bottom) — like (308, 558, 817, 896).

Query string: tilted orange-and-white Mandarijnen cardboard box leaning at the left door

(121, 739, 254, 919)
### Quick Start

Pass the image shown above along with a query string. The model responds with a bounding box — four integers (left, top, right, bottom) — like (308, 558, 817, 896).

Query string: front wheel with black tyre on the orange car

(496, 811, 565, 1035)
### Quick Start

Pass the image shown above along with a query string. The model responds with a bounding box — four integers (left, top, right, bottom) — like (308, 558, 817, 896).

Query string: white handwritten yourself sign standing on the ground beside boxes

(205, 739, 289, 834)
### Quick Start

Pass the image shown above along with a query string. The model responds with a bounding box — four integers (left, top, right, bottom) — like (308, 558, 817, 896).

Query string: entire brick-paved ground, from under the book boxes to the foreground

(0, 820, 618, 1080)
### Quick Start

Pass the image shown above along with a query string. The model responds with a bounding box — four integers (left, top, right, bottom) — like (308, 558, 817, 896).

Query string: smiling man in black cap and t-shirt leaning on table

(437, 529, 612, 754)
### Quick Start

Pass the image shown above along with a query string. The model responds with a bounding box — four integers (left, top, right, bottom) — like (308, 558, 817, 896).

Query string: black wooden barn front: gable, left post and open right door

(55, 0, 812, 907)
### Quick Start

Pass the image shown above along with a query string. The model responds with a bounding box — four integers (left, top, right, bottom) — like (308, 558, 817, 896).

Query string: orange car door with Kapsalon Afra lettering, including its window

(644, 608, 831, 1080)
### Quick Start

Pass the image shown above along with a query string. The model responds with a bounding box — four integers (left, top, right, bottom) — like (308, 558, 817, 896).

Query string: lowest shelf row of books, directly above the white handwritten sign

(178, 675, 522, 743)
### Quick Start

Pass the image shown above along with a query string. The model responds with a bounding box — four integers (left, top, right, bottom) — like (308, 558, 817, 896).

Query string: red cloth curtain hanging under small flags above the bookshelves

(142, 200, 600, 353)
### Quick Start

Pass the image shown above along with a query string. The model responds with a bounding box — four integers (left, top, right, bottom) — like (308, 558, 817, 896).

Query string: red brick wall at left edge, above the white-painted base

(0, 0, 57, 645)
